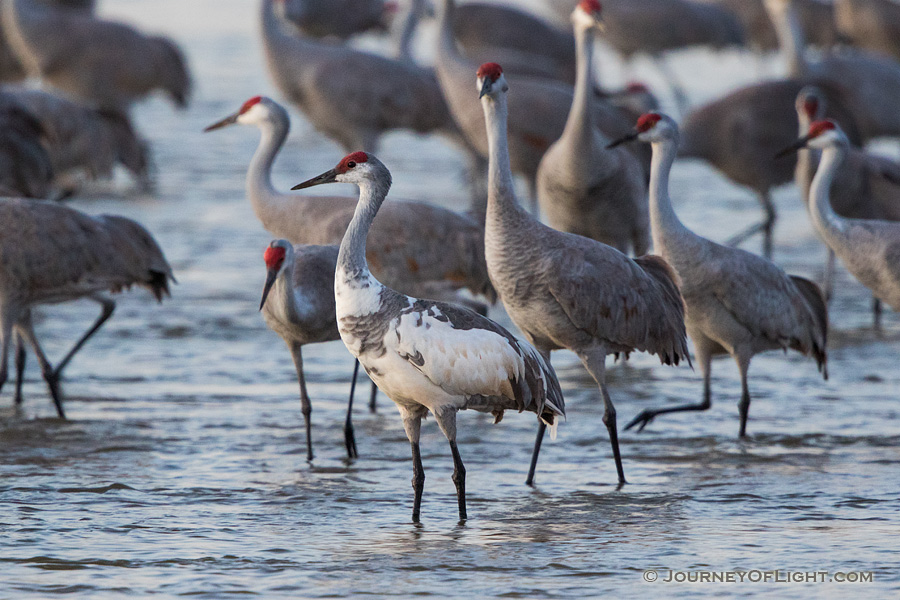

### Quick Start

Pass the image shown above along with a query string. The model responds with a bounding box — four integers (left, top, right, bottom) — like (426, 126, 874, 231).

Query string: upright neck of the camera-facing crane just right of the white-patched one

(481, 92, 531, 237)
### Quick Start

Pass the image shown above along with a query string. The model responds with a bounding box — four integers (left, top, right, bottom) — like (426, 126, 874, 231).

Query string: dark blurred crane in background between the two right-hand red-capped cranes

(679, 79, 865, 258)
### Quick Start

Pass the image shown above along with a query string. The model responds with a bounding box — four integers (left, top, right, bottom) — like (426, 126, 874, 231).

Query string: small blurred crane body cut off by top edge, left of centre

(284, 0, 392, 40)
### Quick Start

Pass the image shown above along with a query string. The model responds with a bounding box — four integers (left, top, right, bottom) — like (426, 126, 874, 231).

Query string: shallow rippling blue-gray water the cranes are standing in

(0, 0, 900, 598)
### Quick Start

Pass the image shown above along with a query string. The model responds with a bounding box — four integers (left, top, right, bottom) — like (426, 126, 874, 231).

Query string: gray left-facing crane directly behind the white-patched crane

(206, 96, 495, 301)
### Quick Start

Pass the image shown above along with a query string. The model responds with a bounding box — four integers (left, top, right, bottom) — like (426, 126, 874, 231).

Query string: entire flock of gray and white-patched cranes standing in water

(0, 0, 900, 521)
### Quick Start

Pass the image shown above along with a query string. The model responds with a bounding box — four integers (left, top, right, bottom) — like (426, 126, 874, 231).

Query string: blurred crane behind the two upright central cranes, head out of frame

(435, 0, 649, 212)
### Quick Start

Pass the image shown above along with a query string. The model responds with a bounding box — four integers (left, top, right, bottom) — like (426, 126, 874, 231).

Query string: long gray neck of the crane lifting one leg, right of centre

(650, 136, 695, 256)
